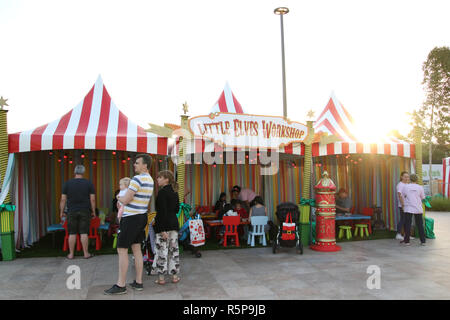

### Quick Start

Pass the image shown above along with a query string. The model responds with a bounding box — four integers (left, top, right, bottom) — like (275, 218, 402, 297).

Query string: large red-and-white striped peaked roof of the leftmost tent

(8, 76, 168, 155)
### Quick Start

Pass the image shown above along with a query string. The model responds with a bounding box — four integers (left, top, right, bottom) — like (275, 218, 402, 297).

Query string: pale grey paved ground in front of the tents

(0, 213, 450, 300)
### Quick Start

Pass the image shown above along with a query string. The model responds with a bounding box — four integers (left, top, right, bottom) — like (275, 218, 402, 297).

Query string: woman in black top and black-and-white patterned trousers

(153, 170, 180, 284)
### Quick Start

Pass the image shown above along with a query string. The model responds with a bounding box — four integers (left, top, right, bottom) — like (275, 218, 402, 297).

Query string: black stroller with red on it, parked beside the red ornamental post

(272, 202, 303, 254)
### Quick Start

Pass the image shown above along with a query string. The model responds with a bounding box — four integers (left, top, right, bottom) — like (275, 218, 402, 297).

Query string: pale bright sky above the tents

(0, 0, 450, 140)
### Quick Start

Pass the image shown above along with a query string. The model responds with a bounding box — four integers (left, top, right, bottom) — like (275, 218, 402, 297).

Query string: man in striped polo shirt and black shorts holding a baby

(104, 154, 153, 295)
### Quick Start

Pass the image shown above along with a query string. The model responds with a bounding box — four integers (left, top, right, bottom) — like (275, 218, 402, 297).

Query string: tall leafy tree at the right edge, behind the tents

(412, 47, 450, 192)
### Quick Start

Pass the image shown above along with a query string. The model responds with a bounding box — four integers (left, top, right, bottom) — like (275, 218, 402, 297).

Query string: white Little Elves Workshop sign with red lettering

(189, 112, 308, 148)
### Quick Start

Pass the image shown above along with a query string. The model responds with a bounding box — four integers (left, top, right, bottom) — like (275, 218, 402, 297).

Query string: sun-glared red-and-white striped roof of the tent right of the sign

(312, 93, 415, 158)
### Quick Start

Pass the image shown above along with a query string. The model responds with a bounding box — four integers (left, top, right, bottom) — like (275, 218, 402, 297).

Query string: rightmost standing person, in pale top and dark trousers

(401, 174, 425, 246)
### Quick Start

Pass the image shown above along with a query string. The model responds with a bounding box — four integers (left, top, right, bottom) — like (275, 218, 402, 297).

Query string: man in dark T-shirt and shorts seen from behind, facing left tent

(59, 165, 95, 259)
